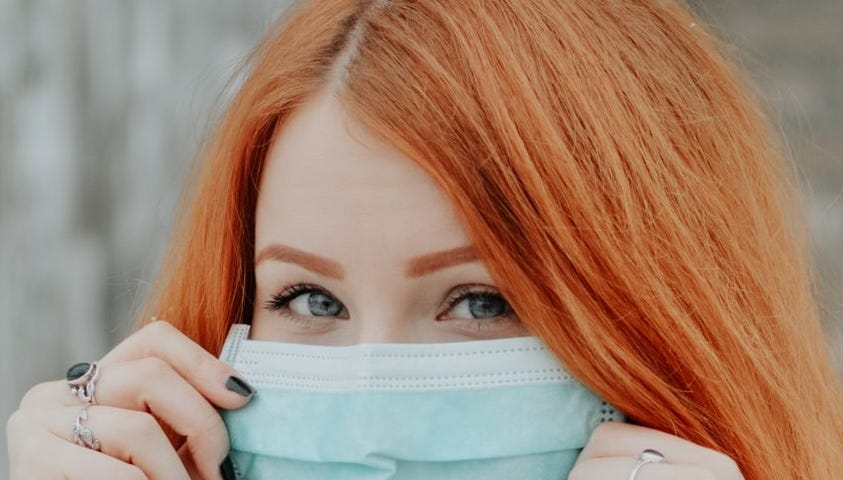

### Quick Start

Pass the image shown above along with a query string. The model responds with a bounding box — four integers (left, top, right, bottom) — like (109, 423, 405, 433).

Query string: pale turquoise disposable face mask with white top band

(220, 325, 623, 480)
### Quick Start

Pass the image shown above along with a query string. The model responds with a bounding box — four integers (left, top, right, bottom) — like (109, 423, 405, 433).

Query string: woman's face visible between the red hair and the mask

(251, 91, 530, 345)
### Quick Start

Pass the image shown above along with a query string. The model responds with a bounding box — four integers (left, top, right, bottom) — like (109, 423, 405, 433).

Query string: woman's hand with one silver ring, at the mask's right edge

(568, 422, 743, 480)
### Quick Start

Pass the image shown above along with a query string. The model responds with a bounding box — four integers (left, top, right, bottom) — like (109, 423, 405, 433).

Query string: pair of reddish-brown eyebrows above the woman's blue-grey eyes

(255, 243, 479, 280)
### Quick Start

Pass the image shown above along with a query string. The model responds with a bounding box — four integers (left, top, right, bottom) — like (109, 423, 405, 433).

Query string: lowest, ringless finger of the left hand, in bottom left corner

(10, 430, 149, 480)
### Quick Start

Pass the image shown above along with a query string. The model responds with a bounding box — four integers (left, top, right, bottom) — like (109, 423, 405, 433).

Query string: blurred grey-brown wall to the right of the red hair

(692, 0, 843, 338)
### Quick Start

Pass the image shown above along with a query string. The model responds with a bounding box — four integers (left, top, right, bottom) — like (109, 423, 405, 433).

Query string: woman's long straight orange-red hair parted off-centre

(138, 0, 843, 480)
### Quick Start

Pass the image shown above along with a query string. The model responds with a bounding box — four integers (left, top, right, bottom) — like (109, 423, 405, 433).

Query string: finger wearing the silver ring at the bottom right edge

(568, 457, 720, 480)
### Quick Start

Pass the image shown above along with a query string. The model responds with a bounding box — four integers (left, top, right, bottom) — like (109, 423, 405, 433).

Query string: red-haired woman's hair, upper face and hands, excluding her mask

(8, 0, 843, 480)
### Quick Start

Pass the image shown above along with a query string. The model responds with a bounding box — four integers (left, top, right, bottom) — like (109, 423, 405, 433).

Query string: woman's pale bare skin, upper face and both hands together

(6, 91, 743, 480)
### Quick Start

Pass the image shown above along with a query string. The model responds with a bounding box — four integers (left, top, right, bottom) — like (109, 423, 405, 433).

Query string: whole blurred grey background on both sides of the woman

(0, 0, 843, 472)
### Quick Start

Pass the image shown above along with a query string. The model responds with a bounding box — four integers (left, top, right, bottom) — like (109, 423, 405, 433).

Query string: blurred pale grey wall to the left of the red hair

(0, 0, 289, 472)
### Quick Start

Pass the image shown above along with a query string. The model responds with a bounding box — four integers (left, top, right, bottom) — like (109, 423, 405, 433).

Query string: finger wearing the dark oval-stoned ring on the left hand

(22, 357, 228, 478)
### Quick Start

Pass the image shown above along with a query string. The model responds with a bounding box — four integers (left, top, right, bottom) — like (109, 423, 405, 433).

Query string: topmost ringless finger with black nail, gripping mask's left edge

(97, 320, 254, 409)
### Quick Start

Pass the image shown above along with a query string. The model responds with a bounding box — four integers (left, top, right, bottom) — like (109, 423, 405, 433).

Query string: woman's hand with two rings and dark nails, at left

(6, 320, 252, 480)
